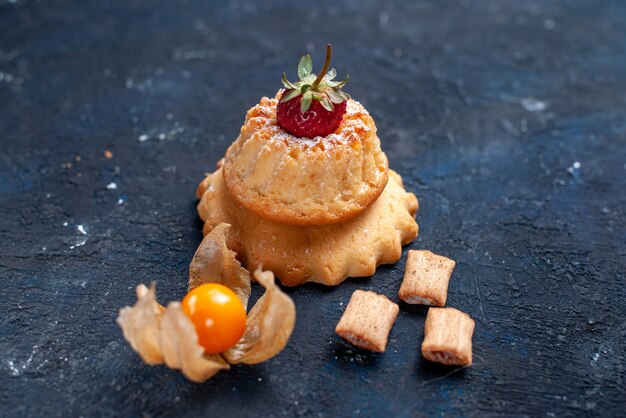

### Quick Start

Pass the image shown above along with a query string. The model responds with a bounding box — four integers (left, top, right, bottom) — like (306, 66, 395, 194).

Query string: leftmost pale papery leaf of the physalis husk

(117, 284, 164, 364)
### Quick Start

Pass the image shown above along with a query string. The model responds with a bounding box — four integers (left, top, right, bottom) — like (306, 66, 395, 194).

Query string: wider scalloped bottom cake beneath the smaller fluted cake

(197, 169, 418, 286)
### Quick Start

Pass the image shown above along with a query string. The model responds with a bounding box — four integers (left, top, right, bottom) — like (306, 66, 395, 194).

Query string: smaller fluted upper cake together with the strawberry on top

(223, 45, 388, 225)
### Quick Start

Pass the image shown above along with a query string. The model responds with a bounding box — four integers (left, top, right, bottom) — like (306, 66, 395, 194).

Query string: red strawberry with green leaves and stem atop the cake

(276, 44, 350, 138)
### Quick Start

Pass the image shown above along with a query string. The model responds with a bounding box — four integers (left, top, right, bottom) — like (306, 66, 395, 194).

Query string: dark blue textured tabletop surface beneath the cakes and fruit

(0, 0, 626, 417)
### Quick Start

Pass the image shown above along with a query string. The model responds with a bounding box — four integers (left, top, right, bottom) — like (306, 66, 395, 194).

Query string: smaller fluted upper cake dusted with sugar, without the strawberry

(223, 97, 389, 225)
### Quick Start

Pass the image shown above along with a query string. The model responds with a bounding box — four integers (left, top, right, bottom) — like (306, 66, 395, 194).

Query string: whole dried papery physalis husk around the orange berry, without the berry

(117, 224, 296, 382)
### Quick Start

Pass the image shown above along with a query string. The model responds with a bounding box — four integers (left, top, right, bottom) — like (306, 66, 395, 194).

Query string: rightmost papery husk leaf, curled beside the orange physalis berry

(223, 269, 296, 364)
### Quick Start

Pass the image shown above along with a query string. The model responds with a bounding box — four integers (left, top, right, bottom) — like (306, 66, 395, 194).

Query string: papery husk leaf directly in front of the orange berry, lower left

(161, 302, 230, 383)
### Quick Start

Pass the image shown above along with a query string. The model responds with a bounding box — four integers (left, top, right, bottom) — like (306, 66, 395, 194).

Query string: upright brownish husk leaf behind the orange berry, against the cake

(188, 223, 251, 309)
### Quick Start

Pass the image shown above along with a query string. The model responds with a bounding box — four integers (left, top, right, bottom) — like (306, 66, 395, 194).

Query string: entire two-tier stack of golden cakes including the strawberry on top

(197, 45, 418, 286)
